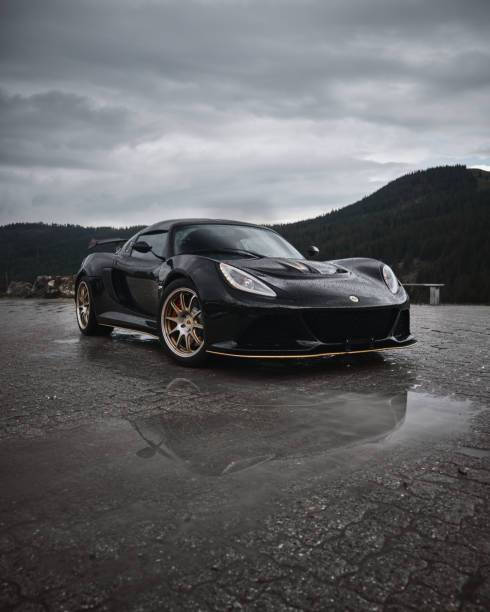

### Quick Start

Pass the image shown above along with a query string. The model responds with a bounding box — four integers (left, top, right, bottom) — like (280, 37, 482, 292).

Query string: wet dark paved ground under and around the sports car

(0, 299, 490, 612)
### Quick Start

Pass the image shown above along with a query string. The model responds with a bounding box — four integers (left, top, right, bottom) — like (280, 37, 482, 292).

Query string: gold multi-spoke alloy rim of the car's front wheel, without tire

(161, 287, 204, 357)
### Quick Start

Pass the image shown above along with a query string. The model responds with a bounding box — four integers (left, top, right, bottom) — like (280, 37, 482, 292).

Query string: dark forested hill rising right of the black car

(274, 166, 490, 303)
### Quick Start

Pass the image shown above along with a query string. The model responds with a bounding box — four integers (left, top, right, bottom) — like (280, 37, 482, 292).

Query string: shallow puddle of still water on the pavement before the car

(0, 388, 472, 529)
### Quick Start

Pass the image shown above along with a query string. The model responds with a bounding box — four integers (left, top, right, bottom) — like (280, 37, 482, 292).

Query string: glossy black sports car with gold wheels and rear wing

(75, 219, 415, 365)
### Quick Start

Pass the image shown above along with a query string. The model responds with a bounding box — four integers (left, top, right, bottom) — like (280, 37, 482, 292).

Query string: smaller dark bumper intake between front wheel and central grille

(238, 315, 305, 349)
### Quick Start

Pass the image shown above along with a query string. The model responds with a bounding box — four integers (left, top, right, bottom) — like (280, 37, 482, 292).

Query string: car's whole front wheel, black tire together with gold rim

(159, 278, 207, 367)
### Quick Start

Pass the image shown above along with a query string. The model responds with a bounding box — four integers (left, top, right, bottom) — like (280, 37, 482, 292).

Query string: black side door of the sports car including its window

(114, 231, 168, 317)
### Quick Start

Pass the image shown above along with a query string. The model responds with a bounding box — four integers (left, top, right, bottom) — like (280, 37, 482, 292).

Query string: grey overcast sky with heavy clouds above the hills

(0, 0, 490, 225)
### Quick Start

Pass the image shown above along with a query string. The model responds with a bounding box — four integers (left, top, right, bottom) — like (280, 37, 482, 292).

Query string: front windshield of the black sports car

(174, 223, 304, 259)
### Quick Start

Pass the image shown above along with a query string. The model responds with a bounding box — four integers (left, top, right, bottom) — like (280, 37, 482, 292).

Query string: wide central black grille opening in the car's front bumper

(303, 308, 398, 344)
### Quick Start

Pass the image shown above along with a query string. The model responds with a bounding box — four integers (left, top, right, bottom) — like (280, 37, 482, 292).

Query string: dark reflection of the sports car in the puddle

(129, 379, 407, 476)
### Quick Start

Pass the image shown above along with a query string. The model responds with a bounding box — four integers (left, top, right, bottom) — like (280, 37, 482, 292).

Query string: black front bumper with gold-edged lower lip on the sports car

(206, 300, 416, 359)
